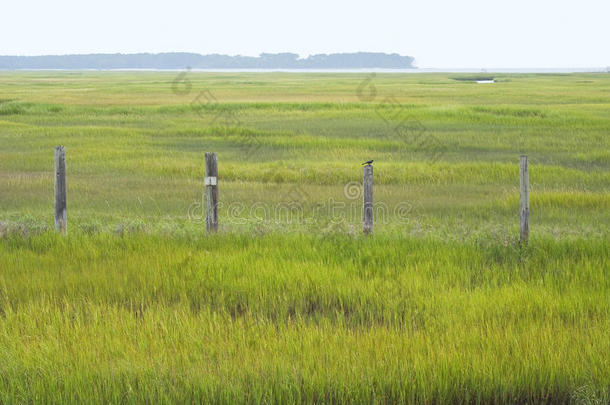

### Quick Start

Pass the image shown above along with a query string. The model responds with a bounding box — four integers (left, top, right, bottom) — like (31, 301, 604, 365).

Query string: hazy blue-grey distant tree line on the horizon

(0, 52, 414, 70)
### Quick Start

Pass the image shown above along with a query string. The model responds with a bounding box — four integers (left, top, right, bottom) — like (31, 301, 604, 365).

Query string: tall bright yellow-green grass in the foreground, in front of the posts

(0, 233, 610, 404)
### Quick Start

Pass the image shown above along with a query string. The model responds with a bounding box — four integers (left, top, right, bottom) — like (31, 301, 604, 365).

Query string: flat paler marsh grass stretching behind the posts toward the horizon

(0, 72, 610, 234)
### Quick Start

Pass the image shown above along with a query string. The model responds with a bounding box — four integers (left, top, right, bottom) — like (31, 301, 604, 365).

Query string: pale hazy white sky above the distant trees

(0, 0, 610, 68)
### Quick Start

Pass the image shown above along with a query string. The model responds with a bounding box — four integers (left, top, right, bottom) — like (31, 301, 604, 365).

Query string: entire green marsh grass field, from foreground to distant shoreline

(0, 72, 610, 404)
